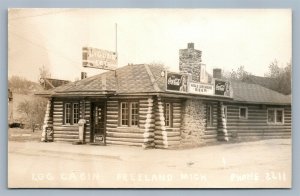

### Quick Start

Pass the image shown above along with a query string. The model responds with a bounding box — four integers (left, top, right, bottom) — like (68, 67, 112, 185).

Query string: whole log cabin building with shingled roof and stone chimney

(40, 43, 292, 148)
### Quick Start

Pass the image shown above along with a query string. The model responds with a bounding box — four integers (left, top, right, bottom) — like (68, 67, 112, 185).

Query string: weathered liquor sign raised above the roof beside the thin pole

(82, 47, 118, 70)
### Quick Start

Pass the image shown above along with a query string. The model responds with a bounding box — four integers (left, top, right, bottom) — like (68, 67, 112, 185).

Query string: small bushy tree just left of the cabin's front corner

(18, 97, 47, 132)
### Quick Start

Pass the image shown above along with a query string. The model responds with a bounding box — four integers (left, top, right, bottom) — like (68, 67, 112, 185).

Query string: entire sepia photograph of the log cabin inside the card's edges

(7, 8, 292, 189)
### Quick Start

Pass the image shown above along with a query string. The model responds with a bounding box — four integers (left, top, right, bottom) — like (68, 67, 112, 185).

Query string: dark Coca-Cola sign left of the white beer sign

(166, 72, 188, 93)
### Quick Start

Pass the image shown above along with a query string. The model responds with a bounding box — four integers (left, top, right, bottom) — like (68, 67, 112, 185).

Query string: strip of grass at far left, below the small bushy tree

(8, 128, 42, 142)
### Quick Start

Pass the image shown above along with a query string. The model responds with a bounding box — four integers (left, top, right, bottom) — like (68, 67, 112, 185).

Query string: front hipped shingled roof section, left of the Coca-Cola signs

(52, 64, 165, 95)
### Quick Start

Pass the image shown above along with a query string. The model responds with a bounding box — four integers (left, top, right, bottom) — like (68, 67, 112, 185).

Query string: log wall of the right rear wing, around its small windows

(224, 103, 291, 140)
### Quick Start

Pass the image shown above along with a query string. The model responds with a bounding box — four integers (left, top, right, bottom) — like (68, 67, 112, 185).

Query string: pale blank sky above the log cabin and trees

(8, 8, 292, 81)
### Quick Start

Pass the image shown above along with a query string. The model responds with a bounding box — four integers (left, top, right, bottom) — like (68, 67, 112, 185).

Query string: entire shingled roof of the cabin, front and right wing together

(46, 64, 291, 104)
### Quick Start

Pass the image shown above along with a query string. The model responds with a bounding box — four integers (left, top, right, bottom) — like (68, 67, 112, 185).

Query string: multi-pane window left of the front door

(64, 103, 79, 124)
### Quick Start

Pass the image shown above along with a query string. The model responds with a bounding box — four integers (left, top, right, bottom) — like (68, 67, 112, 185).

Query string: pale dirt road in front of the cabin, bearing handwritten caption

(8, 139, 291, 188)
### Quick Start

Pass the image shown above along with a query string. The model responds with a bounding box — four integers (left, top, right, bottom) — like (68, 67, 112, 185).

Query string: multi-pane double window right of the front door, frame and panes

(120, 102, 139, 126)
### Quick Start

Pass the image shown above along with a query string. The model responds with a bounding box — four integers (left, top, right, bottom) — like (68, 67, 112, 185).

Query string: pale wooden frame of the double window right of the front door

(119, 100, 140, 127)
